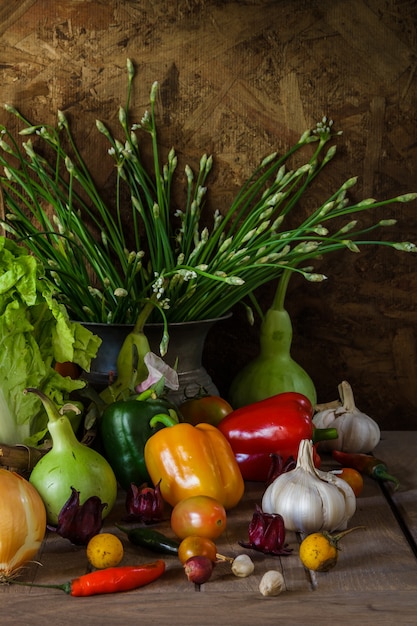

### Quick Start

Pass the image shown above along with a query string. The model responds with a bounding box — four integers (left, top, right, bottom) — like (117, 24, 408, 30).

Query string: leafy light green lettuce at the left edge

(0, 237, 101, 445)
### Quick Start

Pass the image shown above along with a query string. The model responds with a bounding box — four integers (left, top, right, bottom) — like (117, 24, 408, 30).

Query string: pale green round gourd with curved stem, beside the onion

(26, 388, 117, 526)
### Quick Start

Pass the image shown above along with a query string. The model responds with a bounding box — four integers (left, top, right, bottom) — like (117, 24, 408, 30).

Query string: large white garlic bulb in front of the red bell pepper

(262, 439, 356, 533)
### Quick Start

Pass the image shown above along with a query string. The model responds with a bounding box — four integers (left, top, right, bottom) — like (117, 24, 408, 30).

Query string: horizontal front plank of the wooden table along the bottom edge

(1, 590, 416, 626)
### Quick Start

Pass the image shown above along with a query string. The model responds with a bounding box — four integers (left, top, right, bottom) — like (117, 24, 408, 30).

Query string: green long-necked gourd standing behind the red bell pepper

(229, 270, 317, 409)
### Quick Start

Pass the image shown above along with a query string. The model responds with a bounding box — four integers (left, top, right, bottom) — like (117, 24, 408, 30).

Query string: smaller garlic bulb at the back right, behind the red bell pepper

(313, 380, 381, 452)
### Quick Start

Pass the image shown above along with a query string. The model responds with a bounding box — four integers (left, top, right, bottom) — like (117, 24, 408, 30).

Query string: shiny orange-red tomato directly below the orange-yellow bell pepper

(171, 496, 226, 539)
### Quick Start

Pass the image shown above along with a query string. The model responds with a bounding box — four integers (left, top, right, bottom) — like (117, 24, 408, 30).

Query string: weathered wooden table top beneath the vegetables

(0, 431, 417, 626)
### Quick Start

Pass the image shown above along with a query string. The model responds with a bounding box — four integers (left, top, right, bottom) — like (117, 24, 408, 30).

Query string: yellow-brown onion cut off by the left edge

(0, 469, 46, 580)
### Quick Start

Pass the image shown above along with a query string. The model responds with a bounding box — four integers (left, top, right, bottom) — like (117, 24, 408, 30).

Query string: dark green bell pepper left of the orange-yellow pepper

(100, 392, 177, 490)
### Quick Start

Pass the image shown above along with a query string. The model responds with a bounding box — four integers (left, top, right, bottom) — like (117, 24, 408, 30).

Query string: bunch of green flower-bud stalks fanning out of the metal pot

(0, 60, 417, 323)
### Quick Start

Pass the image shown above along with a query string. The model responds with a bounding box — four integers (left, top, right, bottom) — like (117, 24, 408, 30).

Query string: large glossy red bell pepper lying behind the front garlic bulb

(218, 391, 337, 482)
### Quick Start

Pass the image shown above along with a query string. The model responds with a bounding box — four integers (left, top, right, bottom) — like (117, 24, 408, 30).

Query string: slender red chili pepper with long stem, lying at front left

(7, 560, 165, 597)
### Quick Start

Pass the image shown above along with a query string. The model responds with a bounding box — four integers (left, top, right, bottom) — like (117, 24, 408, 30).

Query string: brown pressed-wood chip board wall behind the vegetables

(0, 0, 417, 429)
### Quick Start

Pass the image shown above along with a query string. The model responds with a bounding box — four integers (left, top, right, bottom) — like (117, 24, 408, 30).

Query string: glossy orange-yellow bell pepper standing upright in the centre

(144, 418, 245, 509)
